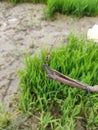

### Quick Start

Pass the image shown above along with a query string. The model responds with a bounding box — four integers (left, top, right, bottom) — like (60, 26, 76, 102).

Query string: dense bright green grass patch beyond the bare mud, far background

(47, 0, 98, 17)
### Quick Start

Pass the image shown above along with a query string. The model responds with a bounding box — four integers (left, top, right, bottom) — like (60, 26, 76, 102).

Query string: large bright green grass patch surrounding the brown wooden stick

(19, 35, 98, 130)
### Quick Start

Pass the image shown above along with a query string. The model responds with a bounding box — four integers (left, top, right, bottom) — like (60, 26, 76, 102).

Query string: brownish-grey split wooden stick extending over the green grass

(43, 64, 98, 92)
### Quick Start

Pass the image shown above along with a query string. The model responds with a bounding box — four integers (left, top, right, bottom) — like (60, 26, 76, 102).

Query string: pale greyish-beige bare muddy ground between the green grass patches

(0, 2, 98, 129)
